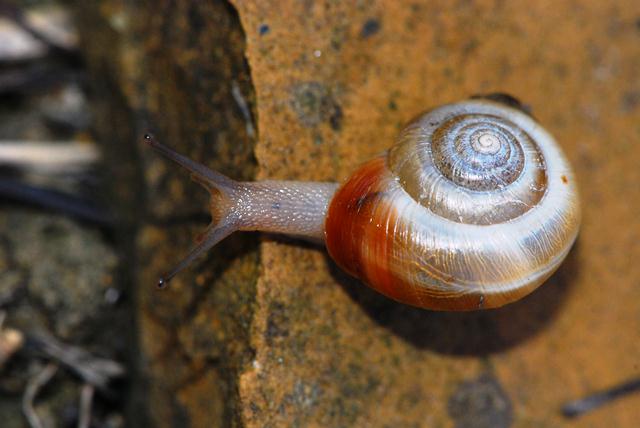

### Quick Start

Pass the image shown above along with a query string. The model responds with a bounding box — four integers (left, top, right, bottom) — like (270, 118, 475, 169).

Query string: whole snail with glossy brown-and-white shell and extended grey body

(145, 98, 580, 311)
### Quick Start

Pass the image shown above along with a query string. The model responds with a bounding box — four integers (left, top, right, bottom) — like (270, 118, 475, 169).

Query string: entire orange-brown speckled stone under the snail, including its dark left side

(79, 0, 640, 427)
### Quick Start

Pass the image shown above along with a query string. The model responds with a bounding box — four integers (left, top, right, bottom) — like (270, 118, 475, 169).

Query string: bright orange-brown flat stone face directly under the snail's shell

(234, 0, 640, 426)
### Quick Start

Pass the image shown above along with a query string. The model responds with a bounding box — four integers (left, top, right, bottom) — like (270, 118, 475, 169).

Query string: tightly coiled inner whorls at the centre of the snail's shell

(389, 101, 555, 225)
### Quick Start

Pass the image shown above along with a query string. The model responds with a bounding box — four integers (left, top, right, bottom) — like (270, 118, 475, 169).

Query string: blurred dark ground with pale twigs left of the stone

(0, 1, 129, 427)
